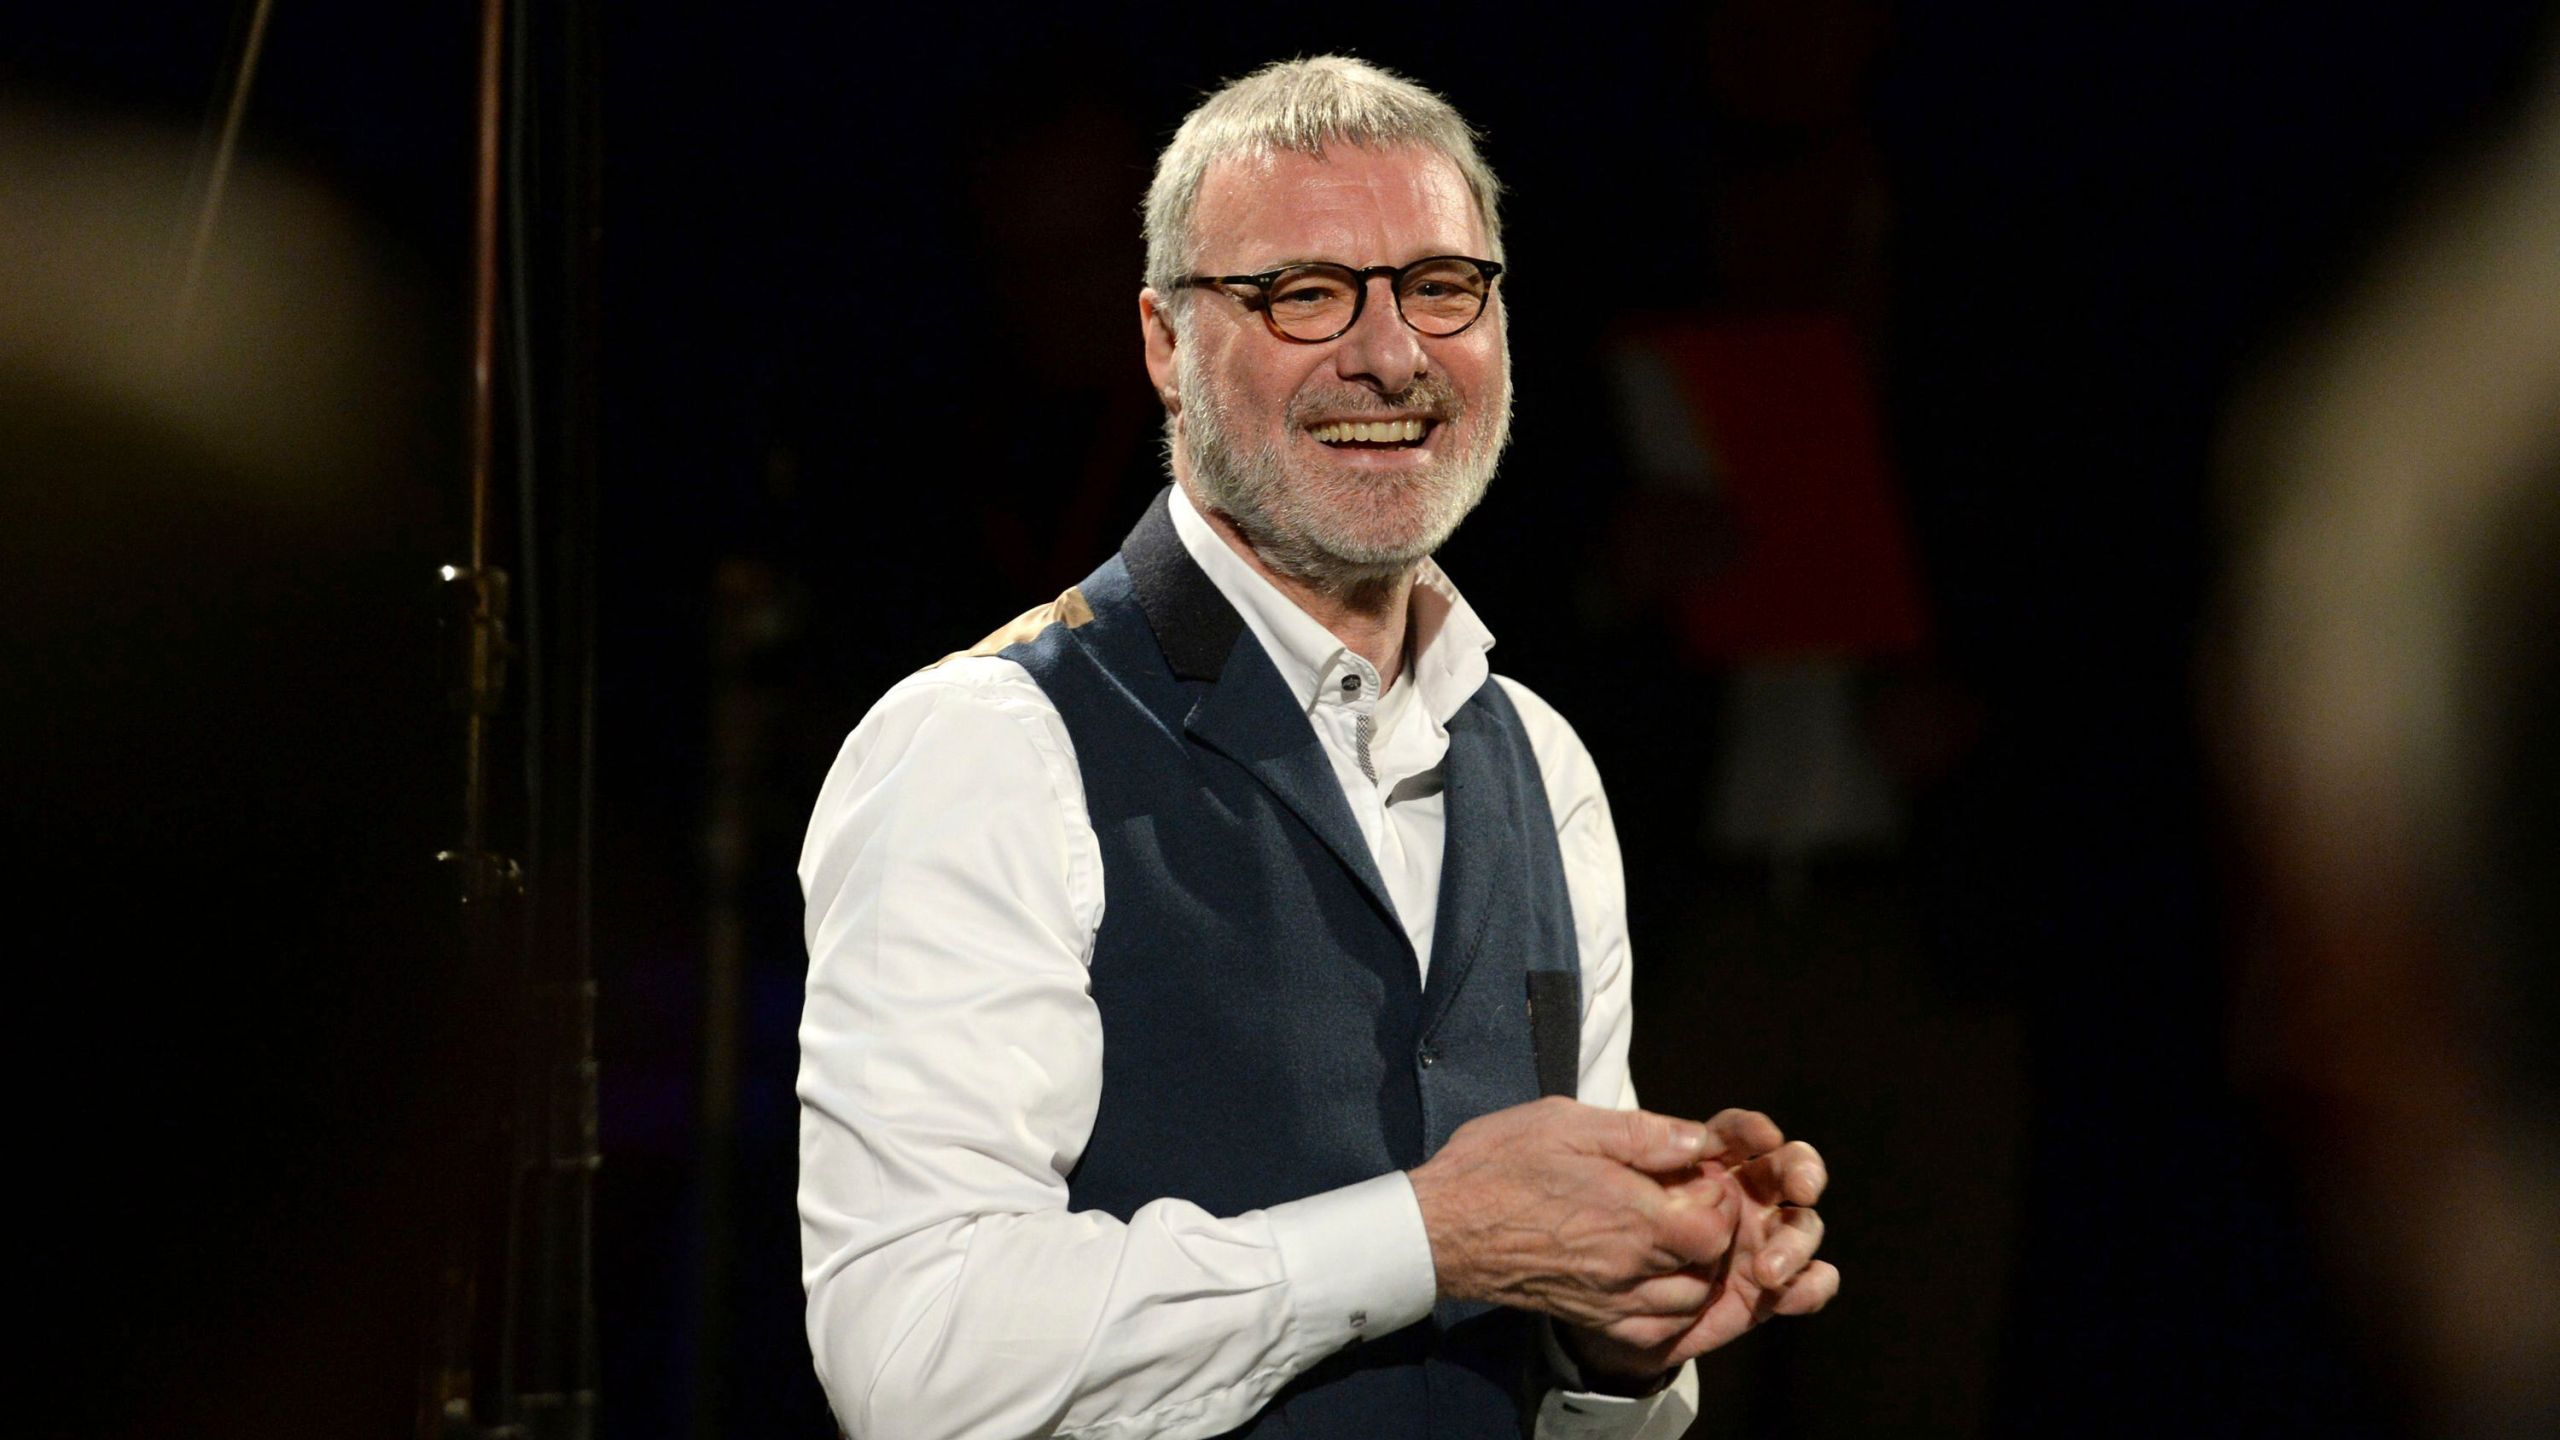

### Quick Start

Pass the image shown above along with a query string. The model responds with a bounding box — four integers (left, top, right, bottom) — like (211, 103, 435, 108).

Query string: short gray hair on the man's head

(1147, 54, 1503, 305)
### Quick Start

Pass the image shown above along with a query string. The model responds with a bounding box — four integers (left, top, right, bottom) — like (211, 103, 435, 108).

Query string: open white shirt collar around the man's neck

(1172, 484, 1492, 728)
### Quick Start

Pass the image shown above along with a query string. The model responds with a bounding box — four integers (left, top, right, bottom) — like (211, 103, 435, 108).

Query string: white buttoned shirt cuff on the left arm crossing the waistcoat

(1265, 1171, 1439, 1363)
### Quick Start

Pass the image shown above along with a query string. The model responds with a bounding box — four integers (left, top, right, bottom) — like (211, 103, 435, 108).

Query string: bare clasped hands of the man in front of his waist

(1411, 1099, 1841, 1381)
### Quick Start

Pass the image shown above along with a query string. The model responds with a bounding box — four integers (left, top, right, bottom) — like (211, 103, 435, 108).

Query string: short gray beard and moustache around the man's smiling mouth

(1165, 338, 1510, 594)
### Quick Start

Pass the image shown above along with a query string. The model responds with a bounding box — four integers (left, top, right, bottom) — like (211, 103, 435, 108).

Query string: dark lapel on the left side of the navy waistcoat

(1121, 489, 1402, 948)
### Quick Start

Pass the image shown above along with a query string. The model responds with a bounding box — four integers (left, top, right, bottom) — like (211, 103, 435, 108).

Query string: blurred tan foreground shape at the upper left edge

(0, 102, 396, 499)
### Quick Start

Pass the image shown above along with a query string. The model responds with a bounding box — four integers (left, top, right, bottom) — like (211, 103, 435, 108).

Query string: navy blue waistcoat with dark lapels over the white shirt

(1004, 495, 1582, 1440)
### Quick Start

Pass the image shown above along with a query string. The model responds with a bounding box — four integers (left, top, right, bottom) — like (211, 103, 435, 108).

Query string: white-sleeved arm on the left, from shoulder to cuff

(799, 659, 1434, 1440)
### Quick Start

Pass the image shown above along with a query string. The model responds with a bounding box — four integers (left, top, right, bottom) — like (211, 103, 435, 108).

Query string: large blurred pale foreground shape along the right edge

(2217, 47, 2560, 1435)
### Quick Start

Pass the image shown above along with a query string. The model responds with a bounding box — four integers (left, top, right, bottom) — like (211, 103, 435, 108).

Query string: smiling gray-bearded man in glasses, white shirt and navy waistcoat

(799, 59, 1838, 1440)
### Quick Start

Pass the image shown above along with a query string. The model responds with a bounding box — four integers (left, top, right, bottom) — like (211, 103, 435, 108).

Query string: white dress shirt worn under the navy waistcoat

(778, 487, 1695, 1440)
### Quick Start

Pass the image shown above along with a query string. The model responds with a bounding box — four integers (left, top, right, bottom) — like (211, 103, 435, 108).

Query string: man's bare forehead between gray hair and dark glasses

(1193, 146, 1485, 274)
